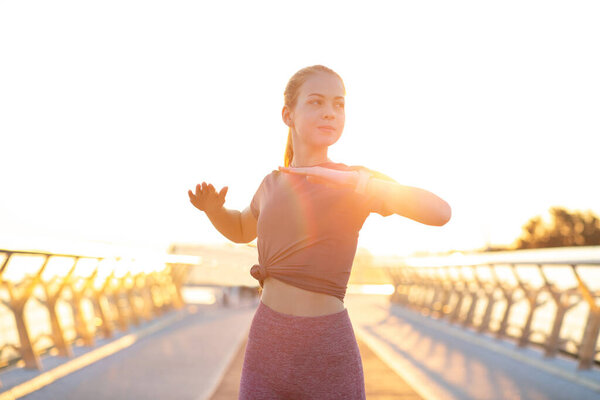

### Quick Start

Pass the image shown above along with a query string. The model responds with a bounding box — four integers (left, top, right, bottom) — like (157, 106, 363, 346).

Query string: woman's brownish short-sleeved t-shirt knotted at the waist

(250, 161, 394, 301)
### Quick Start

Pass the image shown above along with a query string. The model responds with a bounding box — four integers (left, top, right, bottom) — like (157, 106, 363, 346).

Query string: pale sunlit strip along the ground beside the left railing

(0, 311, 187, 400)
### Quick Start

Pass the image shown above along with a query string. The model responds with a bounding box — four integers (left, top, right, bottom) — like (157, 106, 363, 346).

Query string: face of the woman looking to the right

(283, 72, 346, 147)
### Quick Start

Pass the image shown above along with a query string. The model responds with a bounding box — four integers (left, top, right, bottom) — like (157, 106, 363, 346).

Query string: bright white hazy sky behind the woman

(0, 0, 600, 255)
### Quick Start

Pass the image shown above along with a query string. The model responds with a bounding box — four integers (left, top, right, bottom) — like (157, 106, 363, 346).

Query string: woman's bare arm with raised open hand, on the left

(188, 182, 256, 243)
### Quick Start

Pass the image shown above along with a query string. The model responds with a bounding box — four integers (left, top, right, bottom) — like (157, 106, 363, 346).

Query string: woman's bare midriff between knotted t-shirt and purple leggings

(261, 276, 344, 317)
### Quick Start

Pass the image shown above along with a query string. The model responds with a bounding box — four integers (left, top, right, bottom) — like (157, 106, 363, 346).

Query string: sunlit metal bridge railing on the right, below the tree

(387, 255, 600, 369)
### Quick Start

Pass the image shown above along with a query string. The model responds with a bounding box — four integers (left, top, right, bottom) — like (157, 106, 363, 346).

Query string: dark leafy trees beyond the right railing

(516, 207, 600, 249)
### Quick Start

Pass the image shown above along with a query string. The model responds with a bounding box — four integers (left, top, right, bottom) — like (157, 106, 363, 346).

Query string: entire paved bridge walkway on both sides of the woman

(0, 295, 600, 400)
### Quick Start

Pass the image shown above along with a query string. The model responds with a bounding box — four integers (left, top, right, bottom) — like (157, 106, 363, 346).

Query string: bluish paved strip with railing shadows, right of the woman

(346, 295, 600, 400)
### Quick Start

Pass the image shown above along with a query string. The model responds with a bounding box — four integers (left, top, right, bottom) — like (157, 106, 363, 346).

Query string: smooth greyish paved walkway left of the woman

(0, 305, 255, 400)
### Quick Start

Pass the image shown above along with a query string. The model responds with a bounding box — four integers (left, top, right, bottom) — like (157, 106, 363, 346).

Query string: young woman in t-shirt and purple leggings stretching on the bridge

(188, 65, 451, 400)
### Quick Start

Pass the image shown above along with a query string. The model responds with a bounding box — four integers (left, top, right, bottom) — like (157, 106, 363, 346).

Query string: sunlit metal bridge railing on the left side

(0, 249, 187, 387)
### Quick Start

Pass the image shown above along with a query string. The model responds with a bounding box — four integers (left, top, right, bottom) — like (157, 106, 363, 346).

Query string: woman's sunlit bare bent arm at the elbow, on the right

(365, 177, 452, 226)
